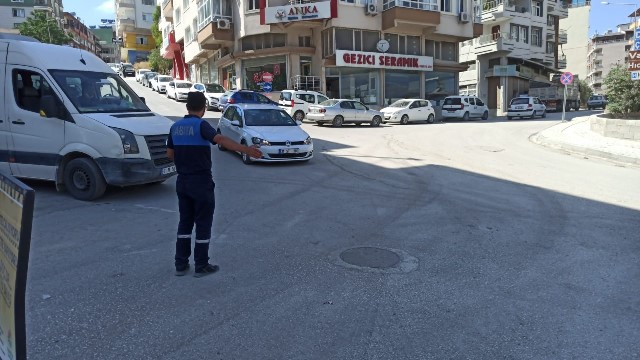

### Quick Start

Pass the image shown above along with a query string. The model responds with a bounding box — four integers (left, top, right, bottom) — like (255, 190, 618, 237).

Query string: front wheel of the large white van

(63, 158, 107, 201)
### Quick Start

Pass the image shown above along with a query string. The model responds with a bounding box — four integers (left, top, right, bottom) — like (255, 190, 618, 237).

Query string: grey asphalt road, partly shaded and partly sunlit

(22, 81, 640, 360)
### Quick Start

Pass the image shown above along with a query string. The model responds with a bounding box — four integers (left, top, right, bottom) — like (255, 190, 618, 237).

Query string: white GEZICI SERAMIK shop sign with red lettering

(336, 50, 433, 71)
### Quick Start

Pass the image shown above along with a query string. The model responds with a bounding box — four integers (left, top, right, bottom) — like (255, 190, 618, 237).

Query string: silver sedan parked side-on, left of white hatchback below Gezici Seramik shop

(307, 99, 384, 127)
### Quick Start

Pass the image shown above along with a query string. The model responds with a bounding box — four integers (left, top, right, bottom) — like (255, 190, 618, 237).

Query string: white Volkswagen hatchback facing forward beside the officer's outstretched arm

(218, 104, 313, 164)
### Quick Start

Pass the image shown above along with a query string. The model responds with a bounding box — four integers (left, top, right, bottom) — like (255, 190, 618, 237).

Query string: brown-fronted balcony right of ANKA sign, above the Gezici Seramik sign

(382, 0, 440, 33)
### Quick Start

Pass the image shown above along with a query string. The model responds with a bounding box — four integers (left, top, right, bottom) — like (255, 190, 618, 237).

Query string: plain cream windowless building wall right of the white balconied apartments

(560, 0, 591, 79)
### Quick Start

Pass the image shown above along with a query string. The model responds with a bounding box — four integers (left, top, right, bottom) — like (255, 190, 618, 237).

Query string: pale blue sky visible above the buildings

(63, 0, 640, 36)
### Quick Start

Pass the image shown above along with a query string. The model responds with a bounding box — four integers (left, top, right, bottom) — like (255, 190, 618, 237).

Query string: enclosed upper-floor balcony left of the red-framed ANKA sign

(197, 0, 233, 50)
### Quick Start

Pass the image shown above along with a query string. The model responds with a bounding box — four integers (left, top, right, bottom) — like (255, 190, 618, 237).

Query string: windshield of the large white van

(49, 70, 151, 114)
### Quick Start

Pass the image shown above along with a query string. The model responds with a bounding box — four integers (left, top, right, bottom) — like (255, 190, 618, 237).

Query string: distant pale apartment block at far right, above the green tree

(586, 24, 633, 94)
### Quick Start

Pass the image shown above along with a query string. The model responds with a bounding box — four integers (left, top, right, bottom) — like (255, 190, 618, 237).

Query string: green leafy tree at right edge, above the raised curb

(604, 66, 640, 117)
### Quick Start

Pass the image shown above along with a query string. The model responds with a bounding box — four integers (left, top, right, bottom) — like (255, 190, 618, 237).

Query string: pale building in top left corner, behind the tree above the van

(0, 0, 64, 33)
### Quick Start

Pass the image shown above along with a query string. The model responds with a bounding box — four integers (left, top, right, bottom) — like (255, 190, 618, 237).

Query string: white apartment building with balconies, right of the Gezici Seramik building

(460, 0, 570, 115)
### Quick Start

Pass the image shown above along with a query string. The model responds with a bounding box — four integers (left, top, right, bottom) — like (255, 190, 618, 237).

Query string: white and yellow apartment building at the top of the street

(115, 0, 156, 64)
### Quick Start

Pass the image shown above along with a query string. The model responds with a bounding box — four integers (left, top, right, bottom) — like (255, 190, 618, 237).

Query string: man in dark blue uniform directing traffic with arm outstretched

(167, 92, 262, 277)
